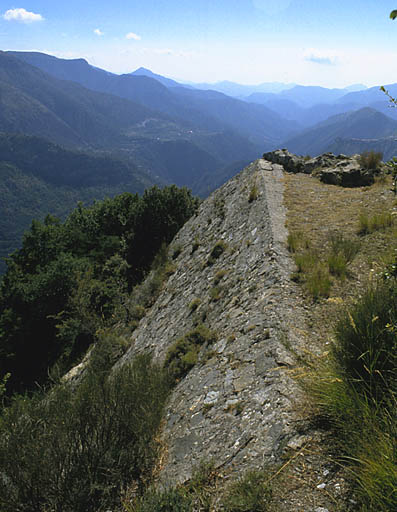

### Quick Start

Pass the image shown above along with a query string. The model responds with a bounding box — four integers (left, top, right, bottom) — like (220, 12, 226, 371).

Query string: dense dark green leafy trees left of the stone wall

(0, 186, 198, 392)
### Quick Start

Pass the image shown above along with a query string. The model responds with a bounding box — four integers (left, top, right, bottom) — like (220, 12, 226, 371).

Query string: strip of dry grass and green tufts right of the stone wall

(286, 171, 397, 512)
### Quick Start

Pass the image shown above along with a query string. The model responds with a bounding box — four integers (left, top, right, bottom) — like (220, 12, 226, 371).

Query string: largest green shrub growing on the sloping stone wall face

(164, 324, 217, 381)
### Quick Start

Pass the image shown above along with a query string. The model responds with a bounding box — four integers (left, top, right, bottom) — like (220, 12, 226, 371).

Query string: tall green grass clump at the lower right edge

(314, 279, 397, 512)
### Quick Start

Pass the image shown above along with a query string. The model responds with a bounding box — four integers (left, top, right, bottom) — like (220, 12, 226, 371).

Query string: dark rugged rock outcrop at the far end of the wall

(263, 149, 378, 187)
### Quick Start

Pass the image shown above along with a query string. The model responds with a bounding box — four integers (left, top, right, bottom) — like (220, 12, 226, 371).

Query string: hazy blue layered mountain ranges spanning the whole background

(0, 51, 397, 270)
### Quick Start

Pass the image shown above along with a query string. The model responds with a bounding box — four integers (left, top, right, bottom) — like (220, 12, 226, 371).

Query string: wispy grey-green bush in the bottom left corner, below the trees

(0, 346, 169, 512)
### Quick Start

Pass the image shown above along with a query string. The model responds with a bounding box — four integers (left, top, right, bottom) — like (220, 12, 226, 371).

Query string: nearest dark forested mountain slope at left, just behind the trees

(0, 133, 153, 274)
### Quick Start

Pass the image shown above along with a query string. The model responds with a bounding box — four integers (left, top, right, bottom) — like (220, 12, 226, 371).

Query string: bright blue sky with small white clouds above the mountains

(0, 0, 397, 87)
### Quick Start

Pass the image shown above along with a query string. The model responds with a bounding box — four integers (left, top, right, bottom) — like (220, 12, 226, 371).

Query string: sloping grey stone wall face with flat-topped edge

(119, 159, 301, 485)
